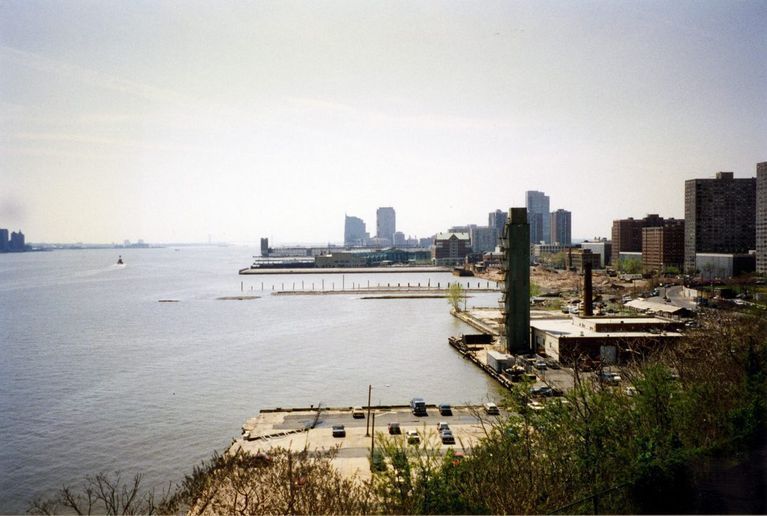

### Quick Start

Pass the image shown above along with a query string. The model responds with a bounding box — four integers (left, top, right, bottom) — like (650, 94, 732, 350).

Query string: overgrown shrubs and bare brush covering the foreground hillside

(32, 314, 767, 514)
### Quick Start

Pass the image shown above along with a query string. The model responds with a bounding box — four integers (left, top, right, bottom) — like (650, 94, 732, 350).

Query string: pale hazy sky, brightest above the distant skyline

(0, 0, 767, 244)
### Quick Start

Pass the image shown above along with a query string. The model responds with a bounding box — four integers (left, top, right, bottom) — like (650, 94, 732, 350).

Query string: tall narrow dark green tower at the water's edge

(501, 208, 532, 355)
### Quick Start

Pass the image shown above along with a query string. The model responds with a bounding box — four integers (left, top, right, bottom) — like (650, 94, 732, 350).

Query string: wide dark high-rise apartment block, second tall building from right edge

(684, 172, 756, 271)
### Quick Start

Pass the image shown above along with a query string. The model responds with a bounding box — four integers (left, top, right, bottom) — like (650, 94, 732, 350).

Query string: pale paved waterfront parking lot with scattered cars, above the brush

(237, 406, 503, 478)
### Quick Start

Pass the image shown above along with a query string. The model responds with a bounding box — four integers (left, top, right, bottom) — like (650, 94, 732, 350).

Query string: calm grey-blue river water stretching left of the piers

(0, 247, 497, 513)
